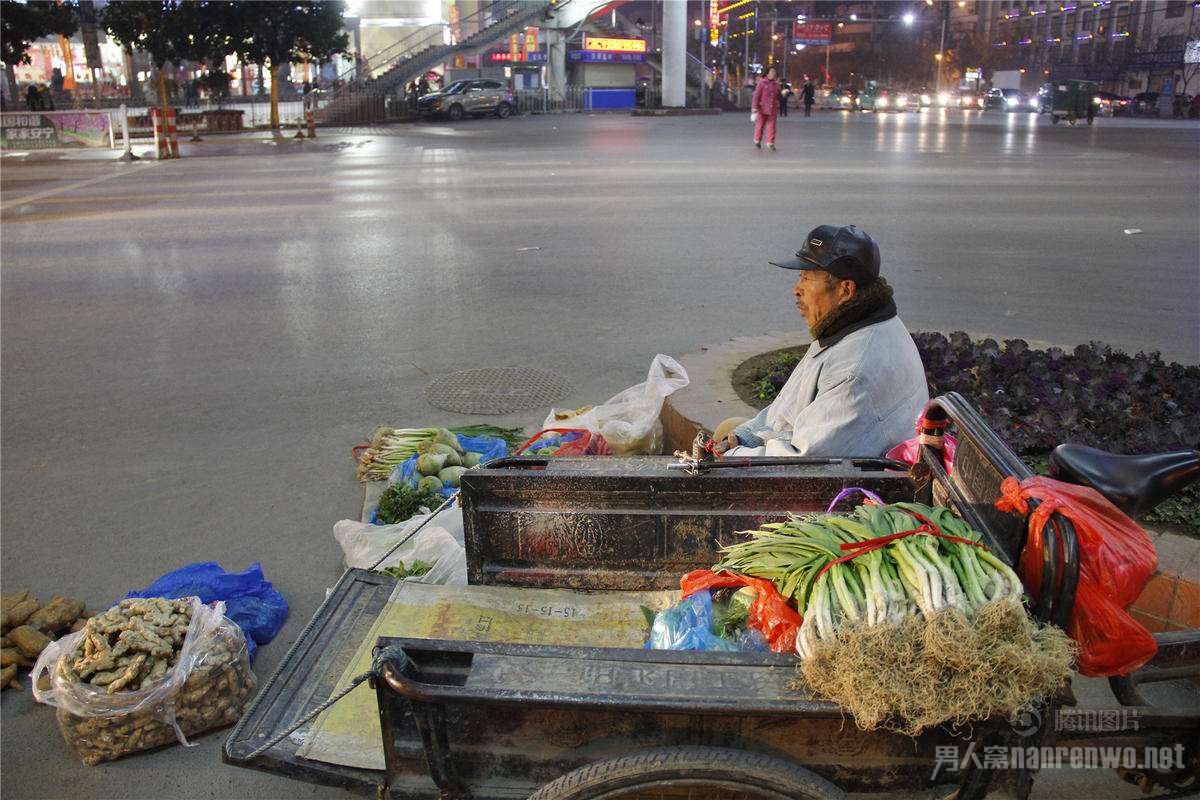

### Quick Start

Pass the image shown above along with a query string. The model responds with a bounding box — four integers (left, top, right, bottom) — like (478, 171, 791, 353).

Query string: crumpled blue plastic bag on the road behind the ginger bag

(125, 561, 288, 661)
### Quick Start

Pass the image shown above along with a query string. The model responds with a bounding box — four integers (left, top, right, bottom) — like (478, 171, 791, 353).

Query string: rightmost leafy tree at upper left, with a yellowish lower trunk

(236, 0, 349, 128)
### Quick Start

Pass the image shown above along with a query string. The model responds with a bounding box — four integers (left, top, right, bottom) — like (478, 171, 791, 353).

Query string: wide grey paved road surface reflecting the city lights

(0, 113, 1200, 799)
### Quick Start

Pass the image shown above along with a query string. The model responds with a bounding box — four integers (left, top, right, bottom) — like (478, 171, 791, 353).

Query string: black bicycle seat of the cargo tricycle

(1050, 445, 1200, 515)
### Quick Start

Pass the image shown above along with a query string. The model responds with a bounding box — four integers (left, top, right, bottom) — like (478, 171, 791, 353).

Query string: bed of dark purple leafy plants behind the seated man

(734, 331, 1200, 536)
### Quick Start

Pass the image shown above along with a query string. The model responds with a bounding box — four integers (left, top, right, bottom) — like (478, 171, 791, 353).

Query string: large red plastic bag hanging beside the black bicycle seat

(996, 475, 1158, 678)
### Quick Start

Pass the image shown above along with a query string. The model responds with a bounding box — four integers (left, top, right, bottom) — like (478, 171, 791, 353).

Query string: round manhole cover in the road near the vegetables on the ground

(425, 367, 570, 414)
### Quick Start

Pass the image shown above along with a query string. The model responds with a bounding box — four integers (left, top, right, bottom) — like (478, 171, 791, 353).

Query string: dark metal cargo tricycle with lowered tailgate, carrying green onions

(224, 393, 1200, 800)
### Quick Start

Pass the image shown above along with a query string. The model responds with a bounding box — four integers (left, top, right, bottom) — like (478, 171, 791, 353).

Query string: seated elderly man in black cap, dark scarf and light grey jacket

(716, 225, 929, 457)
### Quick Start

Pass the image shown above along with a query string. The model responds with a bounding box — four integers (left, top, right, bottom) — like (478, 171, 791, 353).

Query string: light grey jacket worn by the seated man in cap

(730, 317, 929, 457)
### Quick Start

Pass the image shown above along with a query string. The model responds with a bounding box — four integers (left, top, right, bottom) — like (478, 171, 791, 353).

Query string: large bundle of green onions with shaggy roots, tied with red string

(713, 503, 1074, 735)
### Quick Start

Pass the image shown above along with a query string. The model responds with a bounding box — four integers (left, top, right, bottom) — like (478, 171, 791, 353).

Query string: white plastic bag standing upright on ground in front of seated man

(541, 354, 689, 456)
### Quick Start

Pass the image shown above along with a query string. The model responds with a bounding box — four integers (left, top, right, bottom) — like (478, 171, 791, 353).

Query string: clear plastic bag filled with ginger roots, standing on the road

(31, 597, 256, 765)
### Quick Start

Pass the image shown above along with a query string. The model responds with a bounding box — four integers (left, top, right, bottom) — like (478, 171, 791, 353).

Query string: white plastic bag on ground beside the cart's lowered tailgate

(334, 512, 467, 587)
